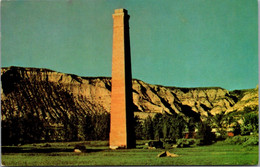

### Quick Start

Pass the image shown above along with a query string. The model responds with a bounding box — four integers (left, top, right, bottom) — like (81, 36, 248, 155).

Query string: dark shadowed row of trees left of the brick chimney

(1, 113, 110, 145)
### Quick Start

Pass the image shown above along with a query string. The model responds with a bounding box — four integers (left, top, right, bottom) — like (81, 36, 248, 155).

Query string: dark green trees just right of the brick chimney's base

(135, 113, 216, 145)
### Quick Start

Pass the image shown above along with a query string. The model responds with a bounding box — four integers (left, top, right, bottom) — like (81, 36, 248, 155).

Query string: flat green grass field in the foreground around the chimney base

(2, 141, 258, 166)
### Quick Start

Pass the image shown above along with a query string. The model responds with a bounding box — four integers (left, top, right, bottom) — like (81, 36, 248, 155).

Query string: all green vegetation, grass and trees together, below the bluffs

(2, 103, 259, 166)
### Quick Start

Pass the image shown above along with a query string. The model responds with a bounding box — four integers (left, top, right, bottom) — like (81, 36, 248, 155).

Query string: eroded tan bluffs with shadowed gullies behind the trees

(1, 67, 258, 123)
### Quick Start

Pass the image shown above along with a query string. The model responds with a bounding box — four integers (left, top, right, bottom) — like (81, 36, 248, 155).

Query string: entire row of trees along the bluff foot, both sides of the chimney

(1, 108, 258, 145)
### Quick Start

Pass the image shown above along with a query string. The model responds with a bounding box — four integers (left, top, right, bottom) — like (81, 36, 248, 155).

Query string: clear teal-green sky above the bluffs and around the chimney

(1, 0, 258, 90)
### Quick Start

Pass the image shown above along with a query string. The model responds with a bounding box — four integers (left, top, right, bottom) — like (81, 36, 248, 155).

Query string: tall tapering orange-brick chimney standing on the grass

(109, 9, 135, 148)
